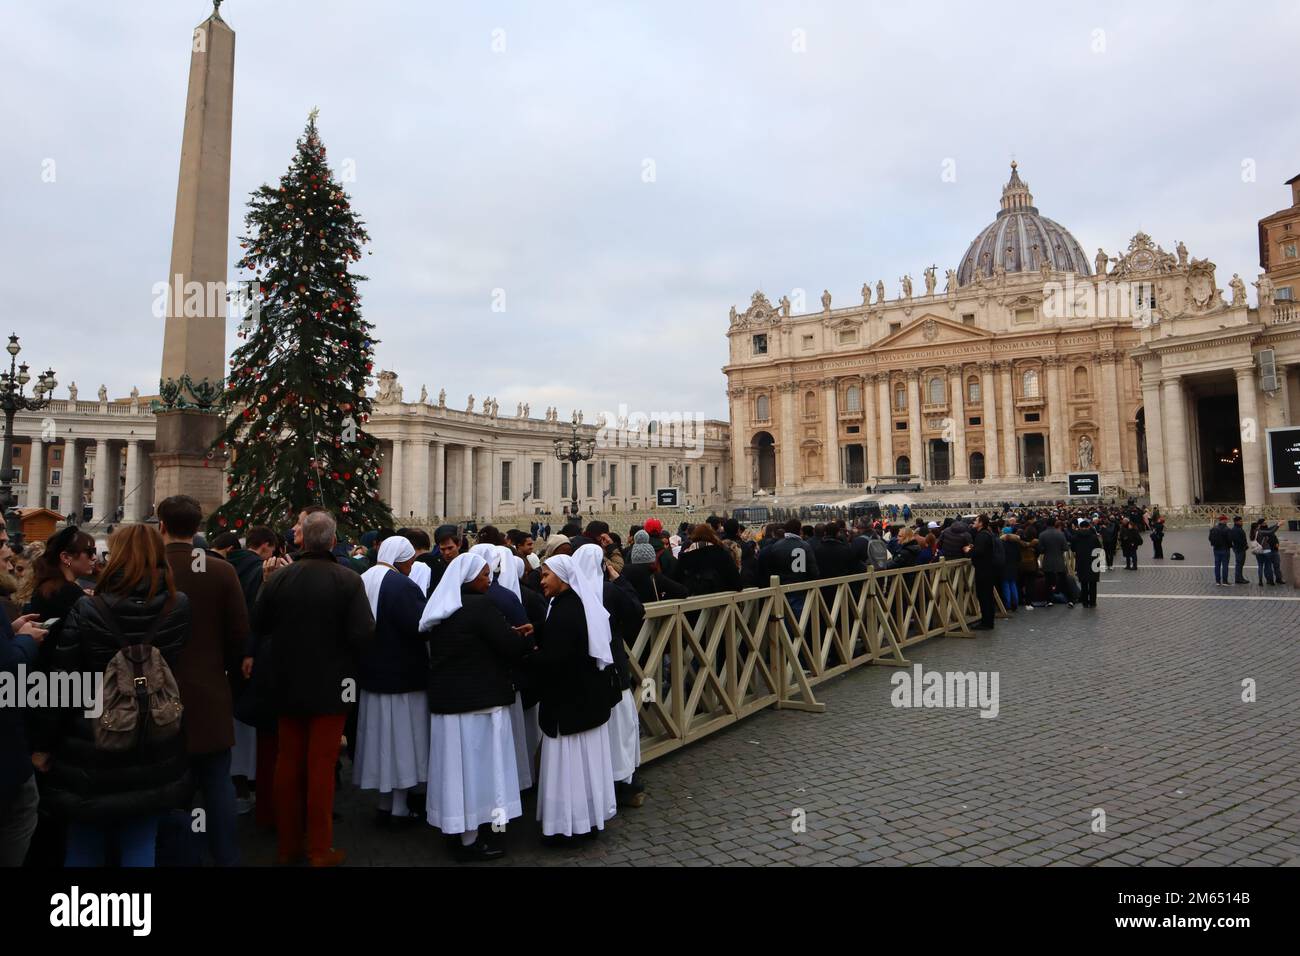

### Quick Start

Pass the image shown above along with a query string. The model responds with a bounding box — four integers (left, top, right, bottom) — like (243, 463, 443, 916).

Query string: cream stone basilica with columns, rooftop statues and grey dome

(723, 163, 1300, 515)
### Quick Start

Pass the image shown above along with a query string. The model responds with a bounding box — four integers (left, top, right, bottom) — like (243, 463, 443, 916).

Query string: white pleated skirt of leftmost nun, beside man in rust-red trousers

(352, 691, 429, 793)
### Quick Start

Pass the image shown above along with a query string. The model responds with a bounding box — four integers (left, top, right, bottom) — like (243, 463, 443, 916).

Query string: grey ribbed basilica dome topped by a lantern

(957, 160, 1092, 285)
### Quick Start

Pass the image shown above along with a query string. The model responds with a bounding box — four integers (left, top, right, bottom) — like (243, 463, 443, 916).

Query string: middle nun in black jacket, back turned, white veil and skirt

(420, 553, 532, 861)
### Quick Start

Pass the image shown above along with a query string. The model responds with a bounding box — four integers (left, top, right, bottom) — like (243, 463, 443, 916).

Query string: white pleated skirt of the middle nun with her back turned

(425, 706, 524, 835)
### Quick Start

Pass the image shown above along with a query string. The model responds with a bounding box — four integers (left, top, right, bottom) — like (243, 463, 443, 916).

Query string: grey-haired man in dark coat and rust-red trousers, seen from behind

(252, 511, 374, 866)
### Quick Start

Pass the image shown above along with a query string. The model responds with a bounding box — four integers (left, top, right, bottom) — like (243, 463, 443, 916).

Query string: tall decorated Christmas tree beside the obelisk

(209, 111, 393, 540)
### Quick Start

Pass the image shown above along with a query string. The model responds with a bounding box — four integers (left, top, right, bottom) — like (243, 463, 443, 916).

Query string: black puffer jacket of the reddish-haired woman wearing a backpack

(42, 585, 192, 825)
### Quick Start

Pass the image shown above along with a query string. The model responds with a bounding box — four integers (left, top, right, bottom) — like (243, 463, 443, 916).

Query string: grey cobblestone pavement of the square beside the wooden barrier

(241, 531, 1300, 866)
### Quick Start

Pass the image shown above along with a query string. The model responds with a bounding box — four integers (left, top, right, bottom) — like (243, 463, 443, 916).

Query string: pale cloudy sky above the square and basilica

(0, 0, 1300, 420)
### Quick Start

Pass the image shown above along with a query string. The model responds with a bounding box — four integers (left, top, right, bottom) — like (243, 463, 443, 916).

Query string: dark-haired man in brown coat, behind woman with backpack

(157, 494, 249, 866)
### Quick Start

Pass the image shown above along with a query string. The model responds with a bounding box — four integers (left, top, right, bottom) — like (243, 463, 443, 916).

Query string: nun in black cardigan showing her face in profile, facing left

(533, 545, 618, 839)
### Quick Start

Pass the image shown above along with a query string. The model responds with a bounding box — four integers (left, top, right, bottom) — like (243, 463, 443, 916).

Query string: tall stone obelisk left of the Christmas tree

(152, 0, 235, 514)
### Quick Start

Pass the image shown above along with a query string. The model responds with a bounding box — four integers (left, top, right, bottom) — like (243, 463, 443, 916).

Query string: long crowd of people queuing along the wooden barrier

(0, 496, 1281, 866)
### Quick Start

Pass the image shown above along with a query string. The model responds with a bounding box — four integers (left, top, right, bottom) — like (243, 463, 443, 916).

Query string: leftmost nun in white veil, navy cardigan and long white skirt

(352, 535, 429, 822)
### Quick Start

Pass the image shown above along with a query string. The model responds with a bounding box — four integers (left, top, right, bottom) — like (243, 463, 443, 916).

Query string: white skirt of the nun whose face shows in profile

(537, 723, 618, 836)
